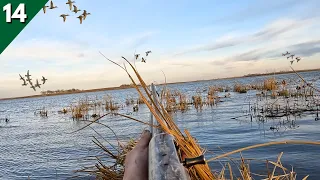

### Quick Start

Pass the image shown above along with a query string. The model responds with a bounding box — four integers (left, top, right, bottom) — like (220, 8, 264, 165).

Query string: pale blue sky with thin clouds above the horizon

(0, 0, 320, 98)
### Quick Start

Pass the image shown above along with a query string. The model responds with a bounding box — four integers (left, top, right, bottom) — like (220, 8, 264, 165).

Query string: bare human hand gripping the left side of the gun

(123, 130, 152, 180)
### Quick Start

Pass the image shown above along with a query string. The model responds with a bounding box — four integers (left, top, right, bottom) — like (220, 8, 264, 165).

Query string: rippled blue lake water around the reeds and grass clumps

(0, 71, 320, 179)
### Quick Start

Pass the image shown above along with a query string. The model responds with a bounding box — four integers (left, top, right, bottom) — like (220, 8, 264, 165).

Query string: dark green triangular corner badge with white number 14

(0, 0, 48, 54)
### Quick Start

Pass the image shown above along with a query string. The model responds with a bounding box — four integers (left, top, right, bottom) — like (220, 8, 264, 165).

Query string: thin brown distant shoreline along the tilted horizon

(0, 68, 320, 101)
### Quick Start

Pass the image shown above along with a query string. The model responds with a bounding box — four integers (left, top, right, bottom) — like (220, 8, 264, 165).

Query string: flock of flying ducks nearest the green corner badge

(42, 0, 91, 24)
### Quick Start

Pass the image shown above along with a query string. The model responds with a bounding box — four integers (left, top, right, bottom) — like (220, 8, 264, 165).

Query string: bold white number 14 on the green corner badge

(3, 3, 27, 23)
